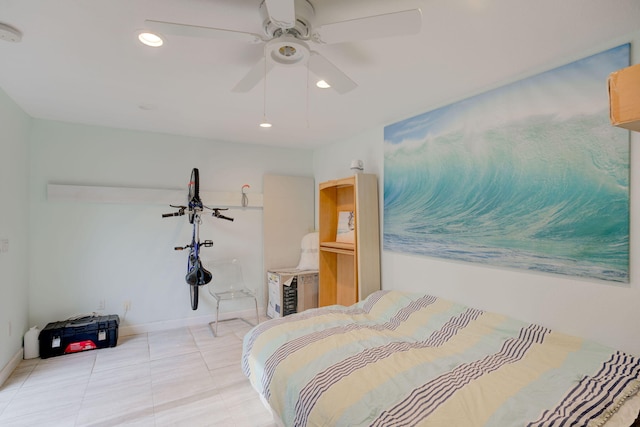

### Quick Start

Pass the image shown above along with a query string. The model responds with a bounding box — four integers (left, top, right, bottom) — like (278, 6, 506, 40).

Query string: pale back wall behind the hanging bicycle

(29, 120, 312, 334)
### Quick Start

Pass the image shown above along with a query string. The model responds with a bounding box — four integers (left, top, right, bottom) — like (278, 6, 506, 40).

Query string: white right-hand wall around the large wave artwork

(314, 40, 640, 355)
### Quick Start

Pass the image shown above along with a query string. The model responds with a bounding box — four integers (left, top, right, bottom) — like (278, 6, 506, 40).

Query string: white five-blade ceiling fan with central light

(145, 0, 422, 94)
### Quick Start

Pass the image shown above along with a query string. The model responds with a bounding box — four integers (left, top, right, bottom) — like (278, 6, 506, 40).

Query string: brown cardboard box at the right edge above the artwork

(608, 64, 640, 132)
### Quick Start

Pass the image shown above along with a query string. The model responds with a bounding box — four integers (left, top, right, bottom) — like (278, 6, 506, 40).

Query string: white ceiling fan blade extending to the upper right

(312, 9, 422, 44)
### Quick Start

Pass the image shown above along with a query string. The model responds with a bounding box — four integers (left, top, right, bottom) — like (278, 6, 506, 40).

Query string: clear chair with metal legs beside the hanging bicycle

(207, 259, 260, 337)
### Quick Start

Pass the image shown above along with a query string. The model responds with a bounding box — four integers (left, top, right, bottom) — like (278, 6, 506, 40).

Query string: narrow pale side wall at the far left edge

(0, 86, 30, 372)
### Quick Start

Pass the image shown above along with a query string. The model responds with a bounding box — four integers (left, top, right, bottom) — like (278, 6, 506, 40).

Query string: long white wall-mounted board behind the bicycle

(47, 184, 263, 209)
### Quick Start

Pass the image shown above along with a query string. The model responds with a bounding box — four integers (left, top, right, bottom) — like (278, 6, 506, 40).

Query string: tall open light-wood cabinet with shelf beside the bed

(318, 174, 380, 307)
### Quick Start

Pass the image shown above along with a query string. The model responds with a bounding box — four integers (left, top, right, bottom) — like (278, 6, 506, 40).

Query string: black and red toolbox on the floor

(38, 314, 120, 359)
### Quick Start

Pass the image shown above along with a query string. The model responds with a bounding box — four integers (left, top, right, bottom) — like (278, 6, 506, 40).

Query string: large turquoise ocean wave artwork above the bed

(384, 45, 629, 282)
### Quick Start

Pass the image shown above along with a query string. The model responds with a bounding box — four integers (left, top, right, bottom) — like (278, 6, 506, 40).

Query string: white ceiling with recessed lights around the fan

(0, 0, 640, 148)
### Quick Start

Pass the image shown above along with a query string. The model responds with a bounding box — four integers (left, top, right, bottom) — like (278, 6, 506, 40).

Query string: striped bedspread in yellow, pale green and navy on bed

(242, 291, 640, 427)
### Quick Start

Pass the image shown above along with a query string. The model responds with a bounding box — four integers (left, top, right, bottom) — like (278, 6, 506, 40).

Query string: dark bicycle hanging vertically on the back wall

(162, 168, 233, 310)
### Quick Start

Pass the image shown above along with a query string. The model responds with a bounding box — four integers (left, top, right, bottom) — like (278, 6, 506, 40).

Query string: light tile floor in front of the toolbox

(0, 320, 277, 427)
